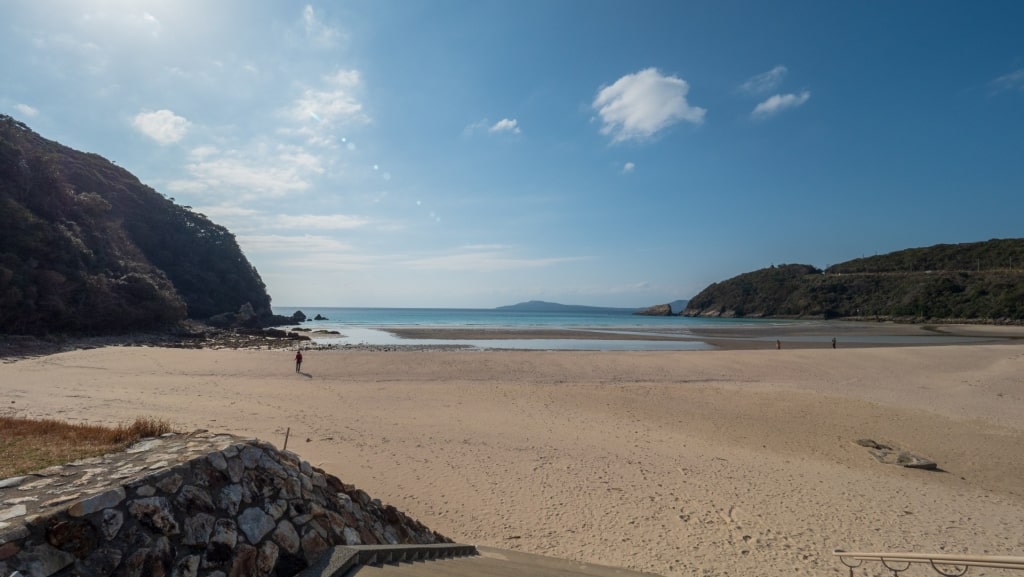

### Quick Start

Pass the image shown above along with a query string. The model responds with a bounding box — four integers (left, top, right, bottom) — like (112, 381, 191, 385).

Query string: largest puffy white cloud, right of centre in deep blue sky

(593, 68, 707, 142)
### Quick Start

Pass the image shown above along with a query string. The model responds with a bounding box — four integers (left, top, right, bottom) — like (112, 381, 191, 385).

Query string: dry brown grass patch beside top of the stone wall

(0, 417, 172, 479)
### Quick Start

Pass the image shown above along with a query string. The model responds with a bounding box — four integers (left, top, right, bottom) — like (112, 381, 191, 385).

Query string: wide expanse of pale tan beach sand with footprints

(0, 344, 1024, 576)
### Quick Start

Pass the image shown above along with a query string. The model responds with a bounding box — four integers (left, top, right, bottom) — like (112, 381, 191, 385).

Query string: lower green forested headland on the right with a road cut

(683, 239, 1024, 322)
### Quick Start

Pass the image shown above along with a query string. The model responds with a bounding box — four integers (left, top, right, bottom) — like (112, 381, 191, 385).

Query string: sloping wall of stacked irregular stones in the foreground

(0, 430, 452, 577)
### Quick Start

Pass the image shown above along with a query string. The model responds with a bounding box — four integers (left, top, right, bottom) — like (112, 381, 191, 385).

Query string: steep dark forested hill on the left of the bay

(0, 115, 270, 334)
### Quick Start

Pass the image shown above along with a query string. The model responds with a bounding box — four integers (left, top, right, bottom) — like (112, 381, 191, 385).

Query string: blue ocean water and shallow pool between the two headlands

(273, 306, 792, 351)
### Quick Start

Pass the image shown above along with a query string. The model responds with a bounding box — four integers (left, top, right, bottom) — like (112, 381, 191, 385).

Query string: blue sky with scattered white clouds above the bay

(0, 0, 1024, 307)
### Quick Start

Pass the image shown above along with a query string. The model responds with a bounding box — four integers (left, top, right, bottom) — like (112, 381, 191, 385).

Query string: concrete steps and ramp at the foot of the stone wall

(296, 544, 656, 577)
